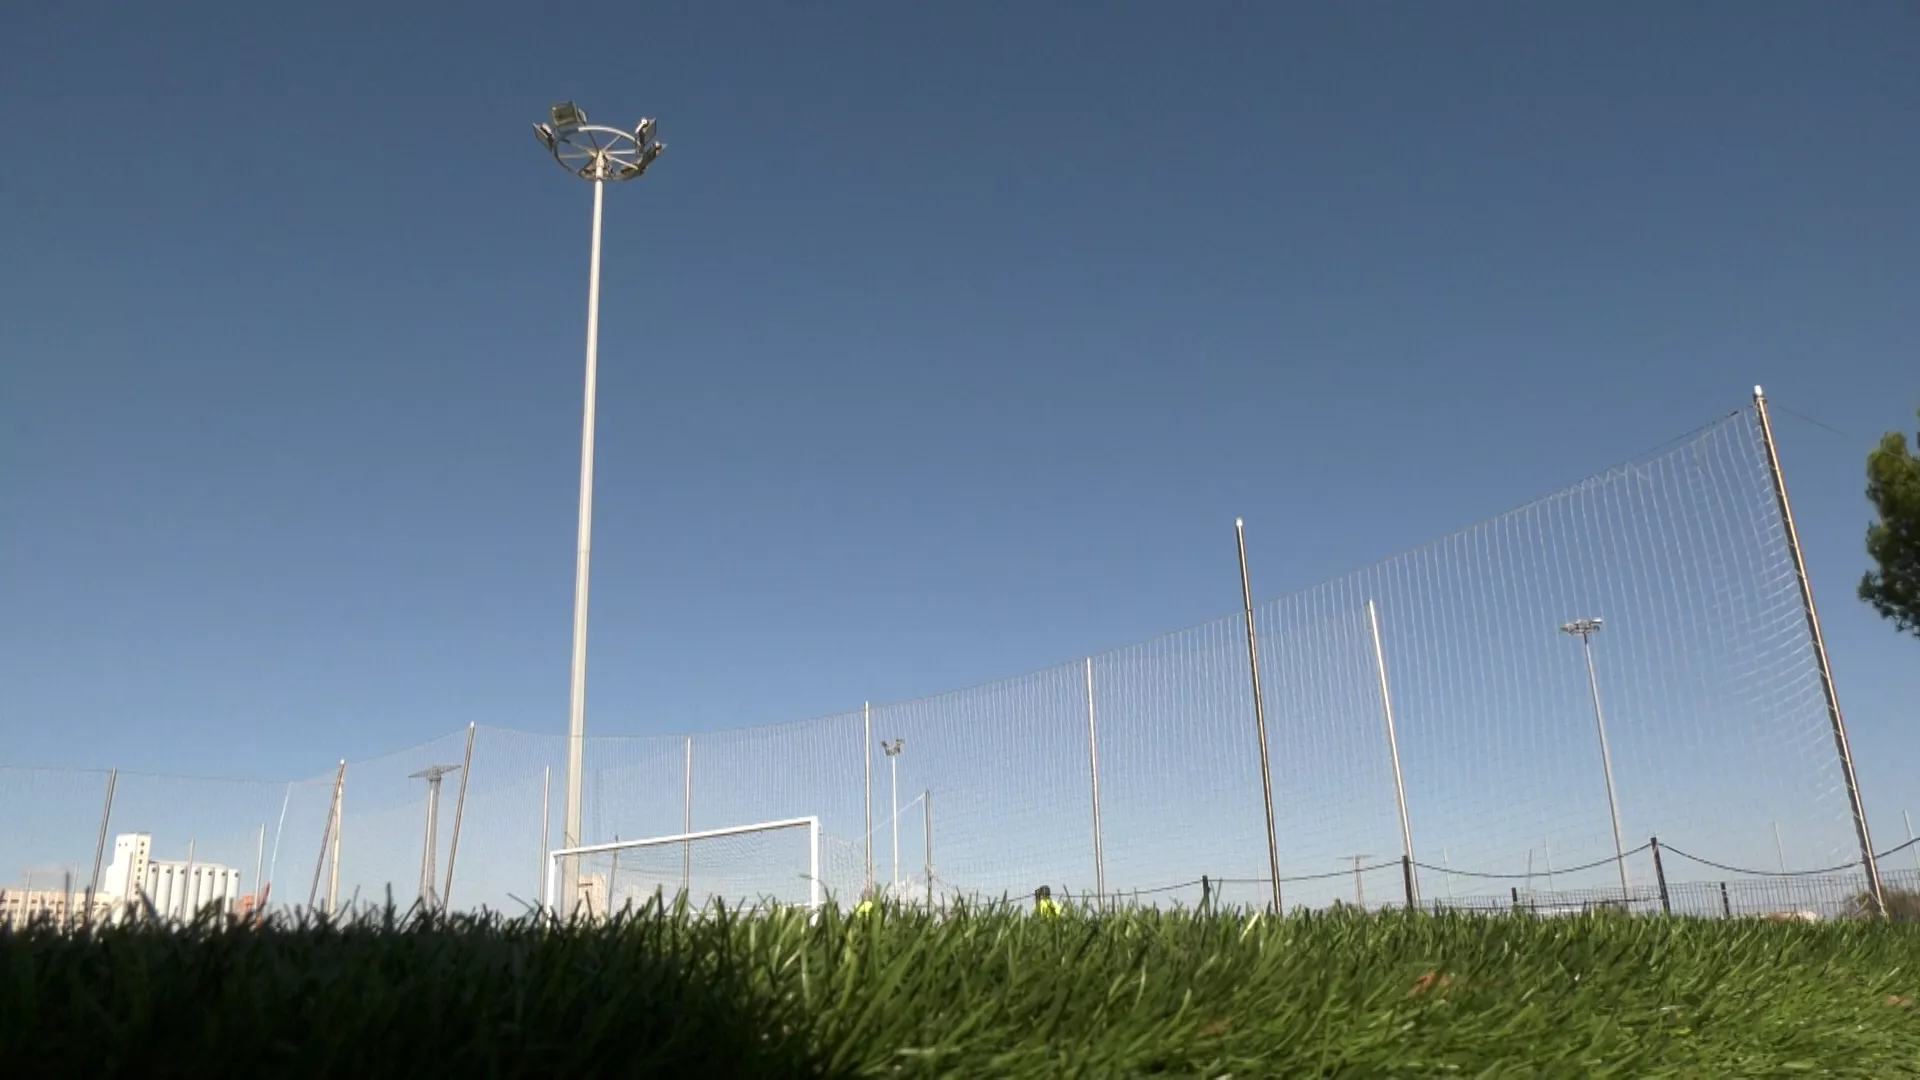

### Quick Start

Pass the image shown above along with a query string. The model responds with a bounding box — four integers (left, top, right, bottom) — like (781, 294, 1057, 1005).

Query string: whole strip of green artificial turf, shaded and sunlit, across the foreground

(0, 909, 1920, 1078)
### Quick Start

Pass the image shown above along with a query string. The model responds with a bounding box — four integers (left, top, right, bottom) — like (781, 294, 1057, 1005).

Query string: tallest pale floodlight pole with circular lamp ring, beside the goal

(534, 102, 666, 909)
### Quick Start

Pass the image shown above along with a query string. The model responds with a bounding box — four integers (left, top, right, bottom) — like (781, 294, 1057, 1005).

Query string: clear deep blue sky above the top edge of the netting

(0, 4, 1920, 853)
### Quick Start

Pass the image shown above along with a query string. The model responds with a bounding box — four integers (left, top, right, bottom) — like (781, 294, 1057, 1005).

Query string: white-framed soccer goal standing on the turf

(547, 817, 822, 917)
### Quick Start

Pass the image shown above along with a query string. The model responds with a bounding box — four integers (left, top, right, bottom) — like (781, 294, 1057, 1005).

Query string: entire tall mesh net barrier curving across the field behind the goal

(0, 399, 1881, 911)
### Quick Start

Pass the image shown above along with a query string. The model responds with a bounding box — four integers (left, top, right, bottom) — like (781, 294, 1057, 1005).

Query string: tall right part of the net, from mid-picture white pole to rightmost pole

(1094, 413, 1859, 905)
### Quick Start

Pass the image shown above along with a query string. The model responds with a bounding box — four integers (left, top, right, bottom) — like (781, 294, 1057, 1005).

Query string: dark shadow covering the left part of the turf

(0, 901, 856, 1078)
